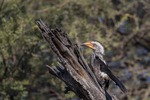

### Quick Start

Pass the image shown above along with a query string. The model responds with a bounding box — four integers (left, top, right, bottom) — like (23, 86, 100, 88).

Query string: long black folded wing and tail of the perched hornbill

(96, 57, 127, 93)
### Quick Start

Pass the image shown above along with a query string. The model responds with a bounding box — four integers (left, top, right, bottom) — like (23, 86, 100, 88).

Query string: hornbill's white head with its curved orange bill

(82, 41, 105, 55)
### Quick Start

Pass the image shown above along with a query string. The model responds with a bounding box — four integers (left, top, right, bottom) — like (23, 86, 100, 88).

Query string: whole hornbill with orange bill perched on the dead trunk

(82, 41, 127, 93)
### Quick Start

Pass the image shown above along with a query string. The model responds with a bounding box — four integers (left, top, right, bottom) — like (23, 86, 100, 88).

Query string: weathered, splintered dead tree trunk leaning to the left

(37, 20, 116, 100)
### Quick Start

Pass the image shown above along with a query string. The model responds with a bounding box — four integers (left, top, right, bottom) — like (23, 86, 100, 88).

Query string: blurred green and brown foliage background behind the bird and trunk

(0, 0, 150, 100)
